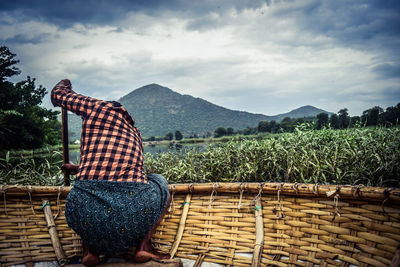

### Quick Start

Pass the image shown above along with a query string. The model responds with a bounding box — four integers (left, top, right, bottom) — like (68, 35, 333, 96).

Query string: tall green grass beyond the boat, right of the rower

(145, 124, 400, 187)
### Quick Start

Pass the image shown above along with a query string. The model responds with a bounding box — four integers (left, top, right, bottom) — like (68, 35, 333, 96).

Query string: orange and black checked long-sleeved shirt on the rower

(51, 80, 148, 183)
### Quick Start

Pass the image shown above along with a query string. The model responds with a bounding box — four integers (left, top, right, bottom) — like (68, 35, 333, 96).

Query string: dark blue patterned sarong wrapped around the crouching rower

(65, 174, 169, 256)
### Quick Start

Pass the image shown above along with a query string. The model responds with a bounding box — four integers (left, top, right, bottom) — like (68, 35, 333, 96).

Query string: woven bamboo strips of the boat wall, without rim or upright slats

(0, 184, 400, 267)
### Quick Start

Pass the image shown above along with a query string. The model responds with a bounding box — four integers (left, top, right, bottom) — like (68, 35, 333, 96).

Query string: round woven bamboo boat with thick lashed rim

(0, 183, 400, 266)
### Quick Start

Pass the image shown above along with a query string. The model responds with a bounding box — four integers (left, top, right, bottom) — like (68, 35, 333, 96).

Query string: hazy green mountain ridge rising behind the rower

(63, 84, 329, 139)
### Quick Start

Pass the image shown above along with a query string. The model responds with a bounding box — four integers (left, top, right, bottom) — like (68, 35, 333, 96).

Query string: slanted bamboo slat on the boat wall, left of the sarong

(42, 199, 66, 266)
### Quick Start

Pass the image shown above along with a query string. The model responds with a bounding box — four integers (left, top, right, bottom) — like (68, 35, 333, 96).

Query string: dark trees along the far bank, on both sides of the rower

(0, 46, 400, 151)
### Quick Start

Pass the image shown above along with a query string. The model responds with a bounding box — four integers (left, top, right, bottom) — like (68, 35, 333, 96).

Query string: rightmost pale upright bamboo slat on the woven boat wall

(251, 197, 264, 267)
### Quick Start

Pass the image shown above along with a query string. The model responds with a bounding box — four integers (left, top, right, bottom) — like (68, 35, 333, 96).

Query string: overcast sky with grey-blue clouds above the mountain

(0, 0, 400, 115)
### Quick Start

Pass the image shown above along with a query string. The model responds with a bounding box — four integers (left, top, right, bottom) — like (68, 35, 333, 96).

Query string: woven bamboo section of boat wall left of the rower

(0, 194, 82, 266)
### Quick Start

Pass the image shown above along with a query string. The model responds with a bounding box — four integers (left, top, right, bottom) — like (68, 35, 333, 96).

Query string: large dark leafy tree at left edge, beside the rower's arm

(0, 46, 61, 150)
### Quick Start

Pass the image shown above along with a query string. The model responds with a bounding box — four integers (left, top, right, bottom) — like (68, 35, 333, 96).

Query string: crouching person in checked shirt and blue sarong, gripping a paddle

(51, 80, 169, 265)
